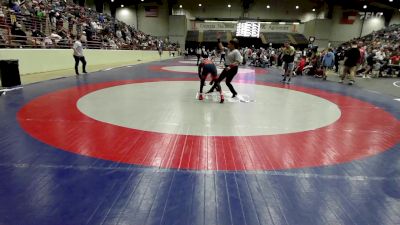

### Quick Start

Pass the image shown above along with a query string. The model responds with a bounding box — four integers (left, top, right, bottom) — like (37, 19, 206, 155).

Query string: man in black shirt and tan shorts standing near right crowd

(339, 43, 361, 85)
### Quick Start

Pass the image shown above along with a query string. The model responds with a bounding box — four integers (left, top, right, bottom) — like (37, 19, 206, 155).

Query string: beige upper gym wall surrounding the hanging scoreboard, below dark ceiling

(83, 0, 400, 48)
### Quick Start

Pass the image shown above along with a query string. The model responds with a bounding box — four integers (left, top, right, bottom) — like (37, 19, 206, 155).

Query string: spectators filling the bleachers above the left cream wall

(0, 0, 179, 50)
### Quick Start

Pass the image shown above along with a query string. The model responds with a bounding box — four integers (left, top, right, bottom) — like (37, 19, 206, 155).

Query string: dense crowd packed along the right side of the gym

(297, 25, 400, 78)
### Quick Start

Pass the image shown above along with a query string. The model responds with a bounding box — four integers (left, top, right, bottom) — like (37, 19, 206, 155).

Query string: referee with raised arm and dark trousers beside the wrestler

(207, 39, 243, 98)
